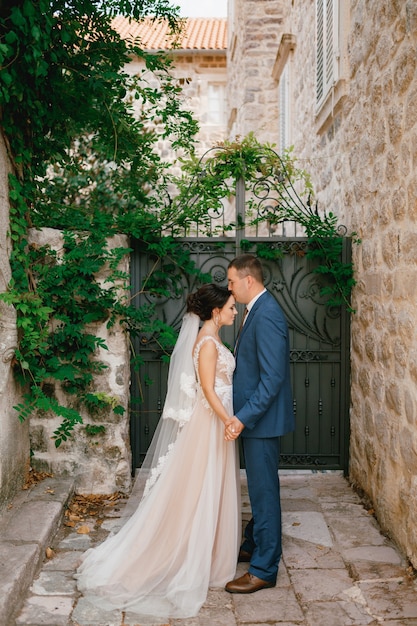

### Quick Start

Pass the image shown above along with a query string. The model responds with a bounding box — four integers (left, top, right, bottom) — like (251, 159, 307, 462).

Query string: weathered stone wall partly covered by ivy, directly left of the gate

(30, 228, 131, 494)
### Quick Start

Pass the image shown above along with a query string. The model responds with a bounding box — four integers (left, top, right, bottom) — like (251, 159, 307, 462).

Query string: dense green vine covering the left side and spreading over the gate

(0, 0, 353, 447)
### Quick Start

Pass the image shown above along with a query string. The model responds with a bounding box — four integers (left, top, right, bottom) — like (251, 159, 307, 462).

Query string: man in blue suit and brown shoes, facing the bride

(225, 254, 294, 593)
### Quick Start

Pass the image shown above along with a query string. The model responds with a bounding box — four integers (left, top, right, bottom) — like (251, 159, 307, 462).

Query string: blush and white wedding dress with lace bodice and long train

(76, 336, 241, 620)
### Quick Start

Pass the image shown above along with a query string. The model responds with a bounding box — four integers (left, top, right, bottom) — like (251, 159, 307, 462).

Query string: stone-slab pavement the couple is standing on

(7, 472, 417, 626)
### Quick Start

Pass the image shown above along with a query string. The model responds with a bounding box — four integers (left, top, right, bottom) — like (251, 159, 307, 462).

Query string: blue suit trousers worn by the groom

(242, 437, 282, 582)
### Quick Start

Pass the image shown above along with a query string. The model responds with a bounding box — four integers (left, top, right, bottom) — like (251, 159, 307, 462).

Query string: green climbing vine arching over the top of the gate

(170, 133, 360, 312)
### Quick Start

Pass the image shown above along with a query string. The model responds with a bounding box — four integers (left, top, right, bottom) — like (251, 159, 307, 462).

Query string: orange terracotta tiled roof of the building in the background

(113, 16, 227, 50)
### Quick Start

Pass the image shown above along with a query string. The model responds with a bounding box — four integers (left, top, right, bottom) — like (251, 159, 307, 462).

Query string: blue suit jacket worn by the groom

(233, 291, 295, 437)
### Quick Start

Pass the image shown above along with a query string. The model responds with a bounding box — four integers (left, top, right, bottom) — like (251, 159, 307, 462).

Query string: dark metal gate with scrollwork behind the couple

(130, 151, 351, 473)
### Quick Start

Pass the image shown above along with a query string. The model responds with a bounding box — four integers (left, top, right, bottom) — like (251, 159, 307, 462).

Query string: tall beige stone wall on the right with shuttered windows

(268, 0, 417, 566)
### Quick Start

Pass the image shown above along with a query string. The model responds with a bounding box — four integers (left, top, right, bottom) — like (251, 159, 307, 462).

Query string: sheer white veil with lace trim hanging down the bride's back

(136, 313, 200, 497)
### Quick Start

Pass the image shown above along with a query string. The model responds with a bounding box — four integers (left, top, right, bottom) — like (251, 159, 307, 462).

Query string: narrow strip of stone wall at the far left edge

(0, 134, 29, 511)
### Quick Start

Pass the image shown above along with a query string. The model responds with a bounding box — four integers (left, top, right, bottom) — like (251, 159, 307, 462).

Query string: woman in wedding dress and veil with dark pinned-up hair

(76, 284, 241, 619)
